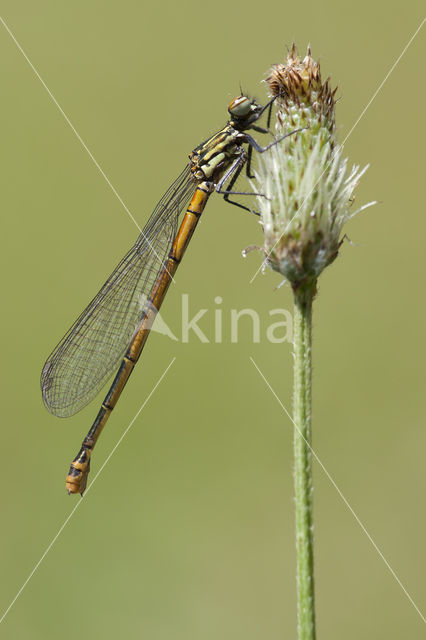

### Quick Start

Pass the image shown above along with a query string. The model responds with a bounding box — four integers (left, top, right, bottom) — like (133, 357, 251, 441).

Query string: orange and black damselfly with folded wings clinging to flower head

(41, 95, 295, 494)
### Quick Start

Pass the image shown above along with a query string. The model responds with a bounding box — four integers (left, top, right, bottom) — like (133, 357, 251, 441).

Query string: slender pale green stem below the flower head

(293, 282, 316, 640)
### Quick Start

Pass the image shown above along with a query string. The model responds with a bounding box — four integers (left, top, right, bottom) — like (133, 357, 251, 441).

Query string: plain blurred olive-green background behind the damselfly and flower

(0, 0, 426, 640)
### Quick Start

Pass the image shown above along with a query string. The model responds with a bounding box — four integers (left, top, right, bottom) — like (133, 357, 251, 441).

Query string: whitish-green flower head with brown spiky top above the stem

(253, 44, 373, 288)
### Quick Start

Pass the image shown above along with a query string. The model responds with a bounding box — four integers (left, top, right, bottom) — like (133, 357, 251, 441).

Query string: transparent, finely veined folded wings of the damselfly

(41, 166, 195, 417)
